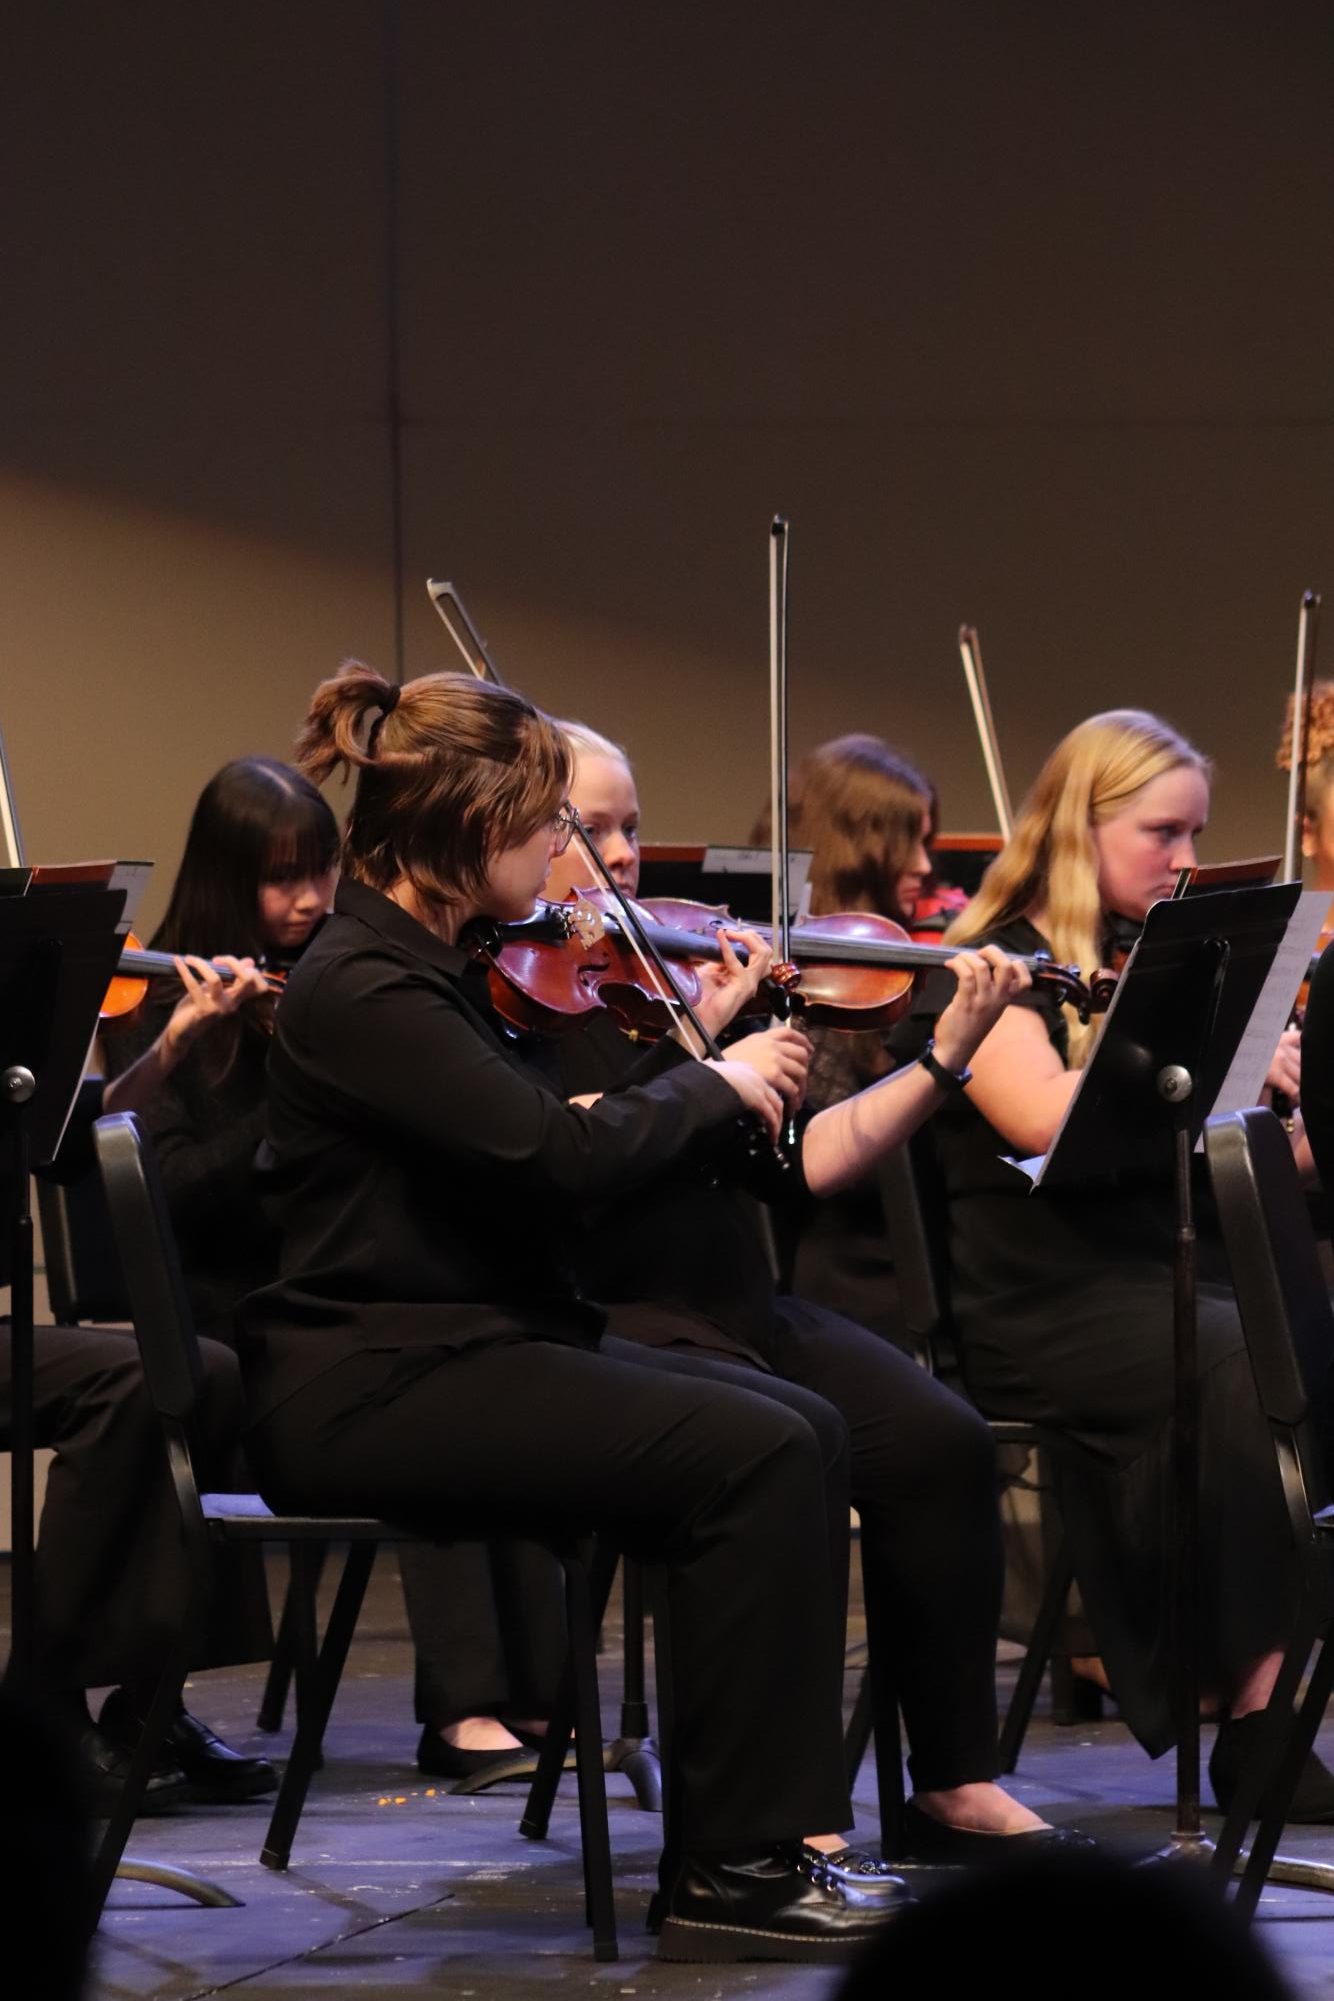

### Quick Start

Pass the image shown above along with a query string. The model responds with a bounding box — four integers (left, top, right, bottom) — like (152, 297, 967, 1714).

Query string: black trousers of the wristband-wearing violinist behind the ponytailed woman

(610, 1297, 1004, 1793)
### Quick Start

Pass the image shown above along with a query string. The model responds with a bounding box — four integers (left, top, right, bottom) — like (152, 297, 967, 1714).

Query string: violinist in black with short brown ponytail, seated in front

(244, 666, 972, 1959)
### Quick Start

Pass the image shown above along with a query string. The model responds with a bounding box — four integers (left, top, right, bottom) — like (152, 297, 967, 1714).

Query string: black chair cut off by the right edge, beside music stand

(1204, 1109, 1334, 1917)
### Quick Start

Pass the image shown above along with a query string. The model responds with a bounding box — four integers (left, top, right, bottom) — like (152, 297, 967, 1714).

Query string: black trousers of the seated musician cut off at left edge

(0, 1321, 272, 1691)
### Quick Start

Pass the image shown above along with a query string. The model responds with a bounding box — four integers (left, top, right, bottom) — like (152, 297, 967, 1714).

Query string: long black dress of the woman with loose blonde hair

(894, 918, 1296, 1755)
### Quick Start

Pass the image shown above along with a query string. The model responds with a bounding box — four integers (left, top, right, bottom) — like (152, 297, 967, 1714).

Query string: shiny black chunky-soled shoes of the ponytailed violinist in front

(658, 1845, 912, 1965)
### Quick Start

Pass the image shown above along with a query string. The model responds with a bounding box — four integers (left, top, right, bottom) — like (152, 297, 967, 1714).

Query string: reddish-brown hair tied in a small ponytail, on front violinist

(296, 660, 570, 902)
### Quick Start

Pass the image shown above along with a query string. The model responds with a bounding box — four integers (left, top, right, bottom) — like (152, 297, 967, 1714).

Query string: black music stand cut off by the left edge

(0, 870, 126, 1685)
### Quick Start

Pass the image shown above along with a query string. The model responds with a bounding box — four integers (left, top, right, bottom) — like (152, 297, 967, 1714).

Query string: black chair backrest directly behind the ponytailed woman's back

(94, 1113, 204, 1437)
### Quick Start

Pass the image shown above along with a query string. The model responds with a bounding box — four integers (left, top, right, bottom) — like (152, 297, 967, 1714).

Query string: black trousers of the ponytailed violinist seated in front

(250, 1341, 852, 1849)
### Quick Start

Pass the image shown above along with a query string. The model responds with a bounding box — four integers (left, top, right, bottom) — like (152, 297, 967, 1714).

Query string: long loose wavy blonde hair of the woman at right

(944, 708, 1212, 1069)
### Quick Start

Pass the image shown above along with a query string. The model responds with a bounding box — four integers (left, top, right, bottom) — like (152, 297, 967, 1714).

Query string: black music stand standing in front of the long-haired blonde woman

(1026, 882, 1302, 1861)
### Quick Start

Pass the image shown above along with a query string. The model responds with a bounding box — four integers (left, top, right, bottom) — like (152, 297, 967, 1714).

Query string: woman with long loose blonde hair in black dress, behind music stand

(896, 710, 1334, 1819)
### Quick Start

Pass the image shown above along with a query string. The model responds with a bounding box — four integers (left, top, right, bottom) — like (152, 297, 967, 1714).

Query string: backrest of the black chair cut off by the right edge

(1204, 1107, 1334, 1509)
